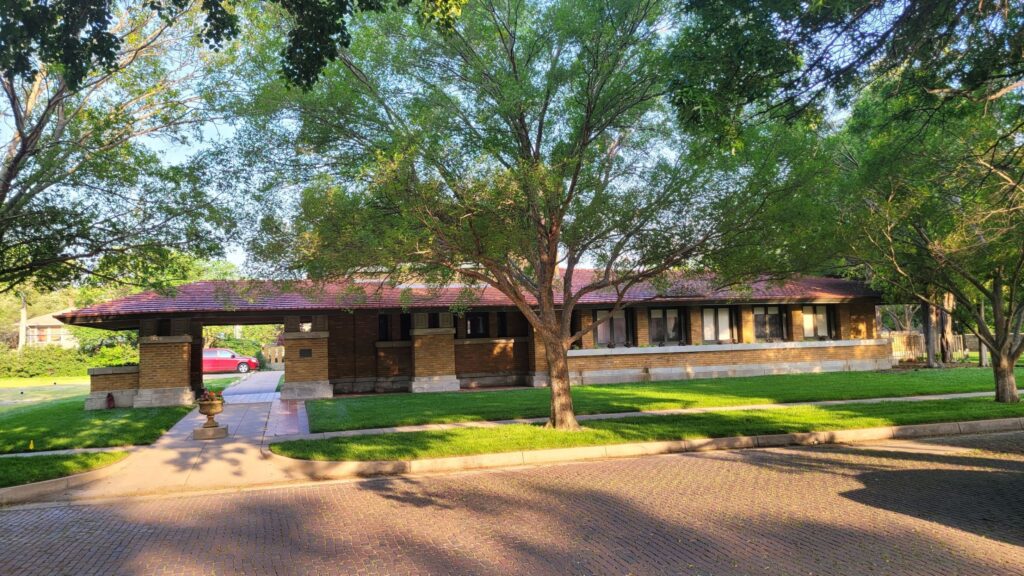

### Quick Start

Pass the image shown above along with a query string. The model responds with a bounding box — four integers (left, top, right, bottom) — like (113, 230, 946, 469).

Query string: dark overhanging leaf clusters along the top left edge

(0, 0, 465, 91)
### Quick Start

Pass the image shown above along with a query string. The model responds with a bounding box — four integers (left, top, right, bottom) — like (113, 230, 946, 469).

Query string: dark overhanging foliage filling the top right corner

(671, 0, 1024, 135)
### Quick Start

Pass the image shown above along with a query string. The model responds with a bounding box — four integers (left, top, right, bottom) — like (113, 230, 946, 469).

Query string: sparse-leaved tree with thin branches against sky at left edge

(0, 4, 232, 292)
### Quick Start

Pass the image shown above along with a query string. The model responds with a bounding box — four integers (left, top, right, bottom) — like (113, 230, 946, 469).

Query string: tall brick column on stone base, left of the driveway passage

(134, 334, 196, 408)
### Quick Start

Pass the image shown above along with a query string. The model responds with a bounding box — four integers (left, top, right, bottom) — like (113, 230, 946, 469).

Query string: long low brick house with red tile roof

(58, 271, 892, 406)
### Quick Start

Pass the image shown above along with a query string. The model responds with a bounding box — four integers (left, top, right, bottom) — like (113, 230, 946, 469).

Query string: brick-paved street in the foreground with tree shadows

(0, 433, 1024, 576)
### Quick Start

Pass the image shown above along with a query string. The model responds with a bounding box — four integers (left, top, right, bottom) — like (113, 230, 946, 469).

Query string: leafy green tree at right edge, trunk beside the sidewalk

(836, 83, 1024, 402)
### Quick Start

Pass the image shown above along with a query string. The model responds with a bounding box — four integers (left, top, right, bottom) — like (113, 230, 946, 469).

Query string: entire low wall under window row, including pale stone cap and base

(568, 339, 893, 384)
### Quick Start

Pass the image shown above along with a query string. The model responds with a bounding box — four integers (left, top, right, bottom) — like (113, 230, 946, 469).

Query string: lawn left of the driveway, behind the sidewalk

(0, 396, 191, 454)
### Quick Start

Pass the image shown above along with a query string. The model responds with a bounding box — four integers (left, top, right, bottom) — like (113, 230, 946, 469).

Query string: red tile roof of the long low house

(58, 271, 879, 323)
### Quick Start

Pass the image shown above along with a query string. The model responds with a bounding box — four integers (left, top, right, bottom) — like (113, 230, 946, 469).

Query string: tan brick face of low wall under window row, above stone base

(569, 343, 891, 372)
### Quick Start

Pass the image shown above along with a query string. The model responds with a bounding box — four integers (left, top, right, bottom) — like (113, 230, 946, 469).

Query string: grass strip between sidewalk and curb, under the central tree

(270, 399, 1024, 460)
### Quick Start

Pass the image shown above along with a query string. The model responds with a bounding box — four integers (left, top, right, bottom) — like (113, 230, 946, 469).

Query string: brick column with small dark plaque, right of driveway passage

(281, 326, 334, 400)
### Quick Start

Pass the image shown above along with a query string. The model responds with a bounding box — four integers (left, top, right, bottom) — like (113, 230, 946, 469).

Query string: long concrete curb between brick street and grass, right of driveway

(260, 418, 1024, 480)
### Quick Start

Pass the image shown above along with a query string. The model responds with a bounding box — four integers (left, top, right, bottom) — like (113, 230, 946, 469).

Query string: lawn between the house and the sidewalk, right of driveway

(306, 368, 1007, 433)
